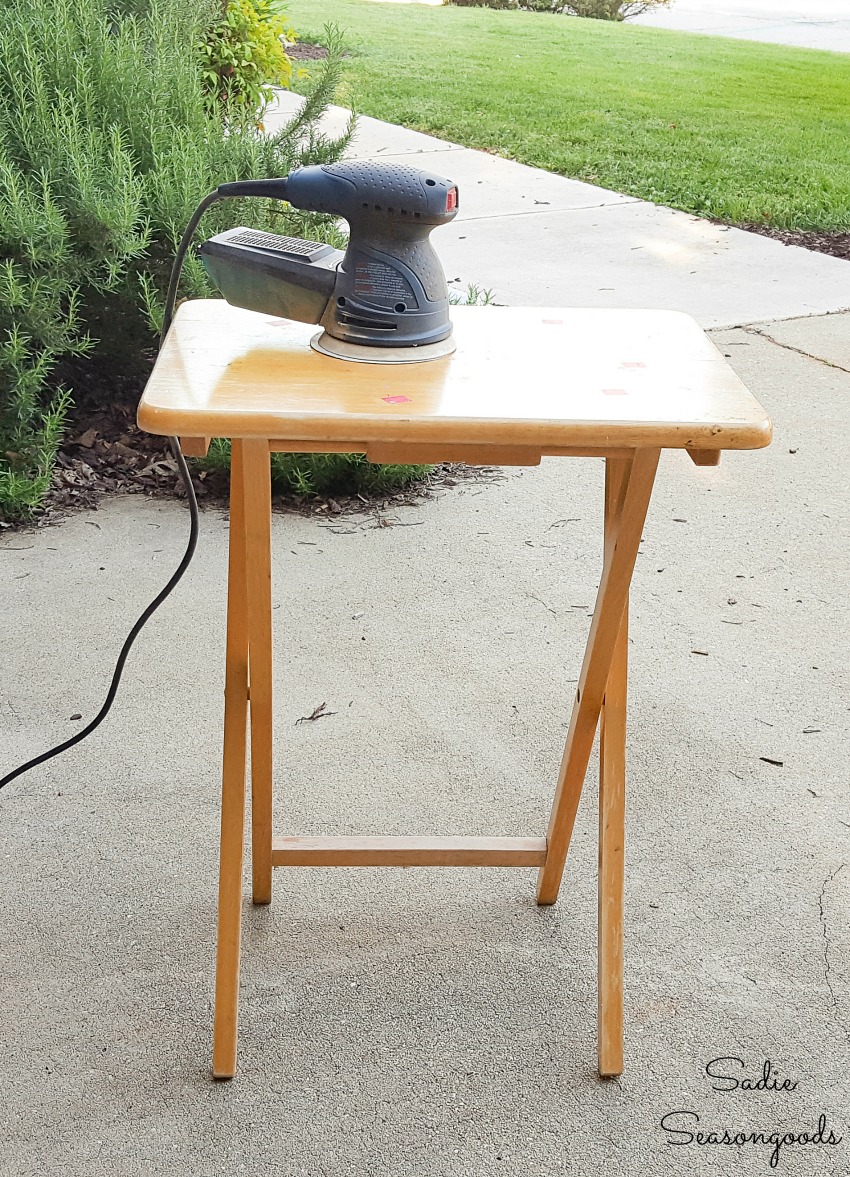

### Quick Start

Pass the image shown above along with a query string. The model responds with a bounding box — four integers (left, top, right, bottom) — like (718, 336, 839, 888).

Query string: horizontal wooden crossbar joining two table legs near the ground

(272, 837, 546, 866)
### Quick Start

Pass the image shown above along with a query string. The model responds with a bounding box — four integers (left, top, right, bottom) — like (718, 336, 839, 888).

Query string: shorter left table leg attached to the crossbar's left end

(241, 438, 272, 904)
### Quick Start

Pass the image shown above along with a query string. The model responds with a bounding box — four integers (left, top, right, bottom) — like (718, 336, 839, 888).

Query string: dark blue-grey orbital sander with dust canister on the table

(199, 160, 458, 364)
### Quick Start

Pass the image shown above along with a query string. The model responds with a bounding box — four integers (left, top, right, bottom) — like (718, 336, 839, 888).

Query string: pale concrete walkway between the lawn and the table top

(265, 92, 850, 328)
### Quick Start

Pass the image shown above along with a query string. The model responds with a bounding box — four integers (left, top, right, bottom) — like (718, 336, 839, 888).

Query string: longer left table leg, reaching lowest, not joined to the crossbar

(213, 441, 248, 1079)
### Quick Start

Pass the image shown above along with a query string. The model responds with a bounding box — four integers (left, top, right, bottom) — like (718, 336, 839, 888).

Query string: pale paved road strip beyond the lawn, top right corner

(635, 0, 850, 53)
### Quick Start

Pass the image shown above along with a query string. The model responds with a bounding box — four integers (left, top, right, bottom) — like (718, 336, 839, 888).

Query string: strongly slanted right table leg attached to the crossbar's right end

(537, 450, 659, 904)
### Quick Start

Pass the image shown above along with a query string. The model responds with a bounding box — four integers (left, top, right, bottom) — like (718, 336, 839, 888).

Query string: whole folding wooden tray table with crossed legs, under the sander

(139, 300, 771, 1078)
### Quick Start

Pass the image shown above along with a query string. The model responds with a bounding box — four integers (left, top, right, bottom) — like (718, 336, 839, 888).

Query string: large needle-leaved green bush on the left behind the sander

(0, 0, 346, 518)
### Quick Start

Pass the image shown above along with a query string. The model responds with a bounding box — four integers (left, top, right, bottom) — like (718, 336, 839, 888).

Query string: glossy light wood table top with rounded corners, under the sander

(139, 299, 771, 452)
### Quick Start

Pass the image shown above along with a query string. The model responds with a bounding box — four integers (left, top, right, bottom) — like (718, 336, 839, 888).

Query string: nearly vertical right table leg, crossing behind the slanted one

(597, 458, 629, 1076)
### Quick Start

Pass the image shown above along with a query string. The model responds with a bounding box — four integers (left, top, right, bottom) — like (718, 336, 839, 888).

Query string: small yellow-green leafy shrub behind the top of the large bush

(200, 0, 300, 118)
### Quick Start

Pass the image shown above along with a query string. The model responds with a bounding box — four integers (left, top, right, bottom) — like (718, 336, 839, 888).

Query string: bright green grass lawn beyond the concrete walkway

(287, 0, 850, 231)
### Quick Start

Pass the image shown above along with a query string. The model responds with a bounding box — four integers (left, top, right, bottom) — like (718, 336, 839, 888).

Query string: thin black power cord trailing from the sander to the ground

(0, 188, 228, 789)
